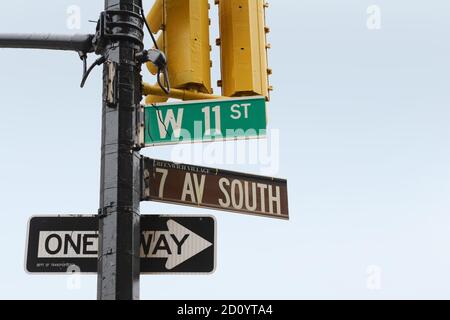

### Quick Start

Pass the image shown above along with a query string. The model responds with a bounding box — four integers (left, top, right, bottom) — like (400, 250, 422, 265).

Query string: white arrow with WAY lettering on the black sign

(141, 220, 212, 270)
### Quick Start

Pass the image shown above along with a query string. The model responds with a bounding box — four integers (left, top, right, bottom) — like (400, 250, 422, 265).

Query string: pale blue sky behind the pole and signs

(0, 0, 450, 299)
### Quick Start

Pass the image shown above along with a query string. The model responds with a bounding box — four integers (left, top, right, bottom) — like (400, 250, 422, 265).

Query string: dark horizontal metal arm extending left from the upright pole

(0, 33, 94, 53)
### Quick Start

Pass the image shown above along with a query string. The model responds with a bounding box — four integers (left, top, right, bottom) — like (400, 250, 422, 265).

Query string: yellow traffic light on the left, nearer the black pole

(147, 0, 212, 102)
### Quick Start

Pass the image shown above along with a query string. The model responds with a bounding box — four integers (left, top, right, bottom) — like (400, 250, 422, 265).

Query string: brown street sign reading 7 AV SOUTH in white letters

(143, 158, 289, 219)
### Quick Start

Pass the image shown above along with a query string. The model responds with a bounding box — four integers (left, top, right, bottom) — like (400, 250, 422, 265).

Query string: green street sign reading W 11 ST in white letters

(143, 96, 267, 147)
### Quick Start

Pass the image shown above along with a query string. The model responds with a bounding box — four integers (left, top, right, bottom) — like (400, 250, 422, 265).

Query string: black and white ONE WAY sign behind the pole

(26, 215, 216, 274)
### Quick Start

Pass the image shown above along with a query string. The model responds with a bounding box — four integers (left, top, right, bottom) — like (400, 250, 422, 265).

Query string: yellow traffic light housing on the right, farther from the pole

(215, 0, 272, 100)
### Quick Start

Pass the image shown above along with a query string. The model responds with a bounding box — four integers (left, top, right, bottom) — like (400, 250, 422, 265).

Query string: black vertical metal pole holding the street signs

(97, 0, 144, 300)
